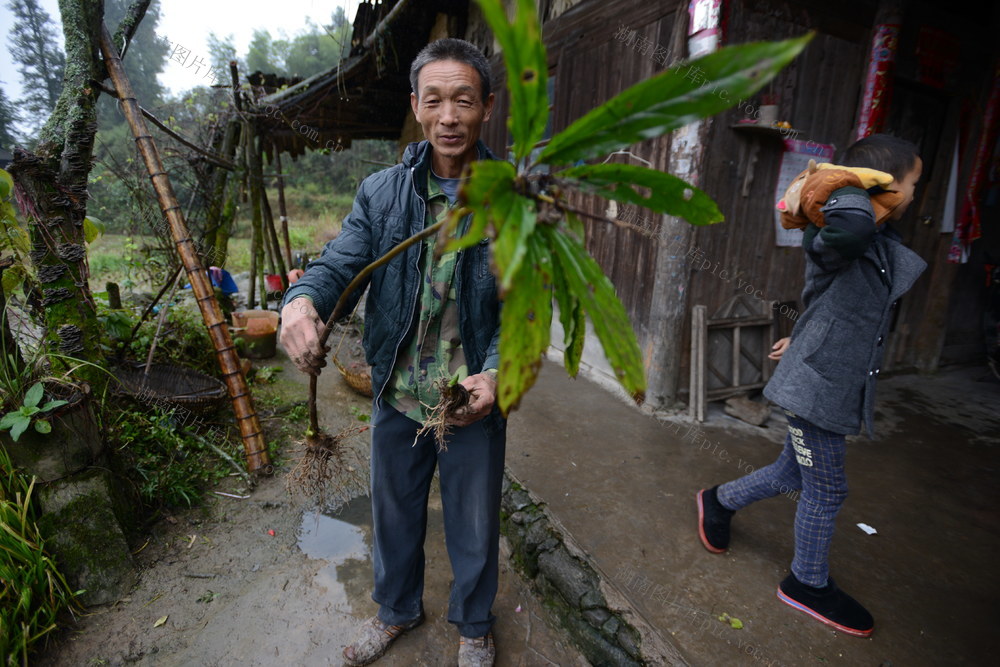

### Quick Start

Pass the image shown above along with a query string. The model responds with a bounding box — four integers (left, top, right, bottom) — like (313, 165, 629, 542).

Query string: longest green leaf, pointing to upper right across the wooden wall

(540, 33, 813, 164)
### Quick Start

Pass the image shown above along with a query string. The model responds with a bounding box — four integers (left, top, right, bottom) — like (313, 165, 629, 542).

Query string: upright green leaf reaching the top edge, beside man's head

(477, 0, 549, 162)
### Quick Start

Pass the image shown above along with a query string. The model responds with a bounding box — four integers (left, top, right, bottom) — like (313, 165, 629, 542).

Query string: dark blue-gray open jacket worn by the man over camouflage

(284, 141, 504, 433)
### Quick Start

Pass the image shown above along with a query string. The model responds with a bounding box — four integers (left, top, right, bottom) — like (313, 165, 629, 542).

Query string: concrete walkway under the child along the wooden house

(507, 362, 1000, 665)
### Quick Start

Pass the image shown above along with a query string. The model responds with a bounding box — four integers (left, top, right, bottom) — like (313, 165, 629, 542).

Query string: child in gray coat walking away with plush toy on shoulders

(697, 135, 926, 637)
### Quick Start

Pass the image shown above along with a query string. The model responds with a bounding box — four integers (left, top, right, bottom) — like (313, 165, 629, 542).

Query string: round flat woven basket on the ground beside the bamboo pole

(114, 362, 228, 412)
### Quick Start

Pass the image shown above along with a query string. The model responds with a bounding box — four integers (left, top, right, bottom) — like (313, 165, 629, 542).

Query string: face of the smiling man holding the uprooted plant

(410, 60, 493, 167)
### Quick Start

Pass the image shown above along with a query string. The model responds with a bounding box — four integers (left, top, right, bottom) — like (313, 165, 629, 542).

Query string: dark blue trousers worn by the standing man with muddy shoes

(371, 401, 507, 637)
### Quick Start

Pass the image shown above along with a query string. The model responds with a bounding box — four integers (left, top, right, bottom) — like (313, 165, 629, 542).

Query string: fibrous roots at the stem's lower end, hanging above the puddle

(285, 426, 369, 513)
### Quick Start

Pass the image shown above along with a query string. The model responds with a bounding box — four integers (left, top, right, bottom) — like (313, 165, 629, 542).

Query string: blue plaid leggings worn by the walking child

(718, 411, 847, 587)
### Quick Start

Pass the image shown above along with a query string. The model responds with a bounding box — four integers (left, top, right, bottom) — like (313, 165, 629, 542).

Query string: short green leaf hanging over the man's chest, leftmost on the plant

(445, 160, 516, 252)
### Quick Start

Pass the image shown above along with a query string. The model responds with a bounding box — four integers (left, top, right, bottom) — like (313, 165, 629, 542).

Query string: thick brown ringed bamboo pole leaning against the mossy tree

(101, 25, 271, 472)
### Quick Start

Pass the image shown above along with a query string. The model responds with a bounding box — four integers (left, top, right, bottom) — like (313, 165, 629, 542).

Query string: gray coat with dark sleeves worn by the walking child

(764, 187, 927, 435)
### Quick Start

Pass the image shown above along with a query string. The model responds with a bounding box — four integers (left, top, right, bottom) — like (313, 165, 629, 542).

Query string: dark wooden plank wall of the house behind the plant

(466, 0, 995, 392)
